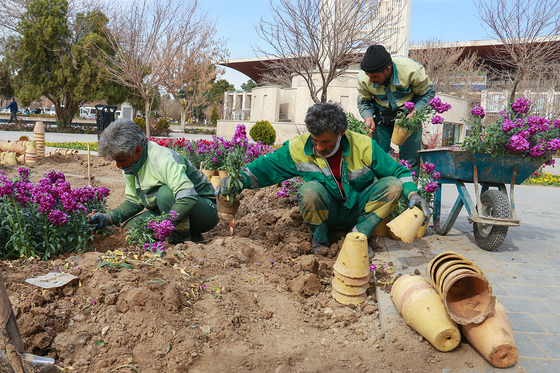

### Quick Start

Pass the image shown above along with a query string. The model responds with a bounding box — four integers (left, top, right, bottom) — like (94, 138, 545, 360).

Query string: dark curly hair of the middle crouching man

(305, 101, 348, 136)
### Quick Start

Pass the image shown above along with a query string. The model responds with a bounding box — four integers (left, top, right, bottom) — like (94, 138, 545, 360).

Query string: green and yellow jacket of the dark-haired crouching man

(242, 130, 418, 208)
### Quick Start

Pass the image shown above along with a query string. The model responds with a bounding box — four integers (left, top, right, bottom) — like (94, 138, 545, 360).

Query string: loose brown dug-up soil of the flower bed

(0, 154, 486, 373)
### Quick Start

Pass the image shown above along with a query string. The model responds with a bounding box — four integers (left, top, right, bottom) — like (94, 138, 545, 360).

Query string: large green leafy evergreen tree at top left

(6, 0, 124, 127)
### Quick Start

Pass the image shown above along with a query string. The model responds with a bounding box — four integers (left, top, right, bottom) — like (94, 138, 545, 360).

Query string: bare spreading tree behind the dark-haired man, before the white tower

(254, 0, 402, 102)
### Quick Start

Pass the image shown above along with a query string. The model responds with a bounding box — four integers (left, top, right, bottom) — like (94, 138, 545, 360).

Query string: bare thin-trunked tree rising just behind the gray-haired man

(95, 0, 197, 137)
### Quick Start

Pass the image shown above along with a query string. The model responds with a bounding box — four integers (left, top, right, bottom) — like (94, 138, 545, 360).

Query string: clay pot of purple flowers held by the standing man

(391, 97, 451, 146)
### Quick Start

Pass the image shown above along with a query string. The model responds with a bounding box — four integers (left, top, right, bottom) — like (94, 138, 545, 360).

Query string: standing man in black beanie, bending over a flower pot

(358, 45, 435, 175)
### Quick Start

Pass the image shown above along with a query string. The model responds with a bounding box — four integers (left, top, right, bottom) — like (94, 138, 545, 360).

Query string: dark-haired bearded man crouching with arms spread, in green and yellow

(218, 103, 429, 256)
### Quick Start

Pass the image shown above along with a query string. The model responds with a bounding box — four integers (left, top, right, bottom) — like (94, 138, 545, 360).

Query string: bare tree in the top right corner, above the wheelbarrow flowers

(475, 0, 560, 102)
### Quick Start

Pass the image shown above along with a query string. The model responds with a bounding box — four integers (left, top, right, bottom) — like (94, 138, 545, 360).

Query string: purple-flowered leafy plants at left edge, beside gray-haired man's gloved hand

(0, 167, 109, 259)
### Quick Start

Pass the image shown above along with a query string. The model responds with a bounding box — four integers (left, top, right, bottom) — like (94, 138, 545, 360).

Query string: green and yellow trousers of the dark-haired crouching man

(298, 176, 402, 243)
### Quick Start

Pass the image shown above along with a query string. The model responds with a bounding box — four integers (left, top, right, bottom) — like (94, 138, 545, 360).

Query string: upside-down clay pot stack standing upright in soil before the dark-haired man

(332, 232, 370, 304)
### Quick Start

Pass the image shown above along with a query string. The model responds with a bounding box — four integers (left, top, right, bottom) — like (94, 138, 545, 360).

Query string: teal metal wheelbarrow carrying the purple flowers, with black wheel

(419, 148, 544, 251)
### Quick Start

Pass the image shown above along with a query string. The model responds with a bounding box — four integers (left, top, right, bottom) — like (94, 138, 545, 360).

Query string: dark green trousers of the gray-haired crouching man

(123, 185, 220, 243)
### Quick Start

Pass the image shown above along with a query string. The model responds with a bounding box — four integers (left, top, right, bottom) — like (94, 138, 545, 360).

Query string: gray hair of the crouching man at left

(98, 118, 148, 158)
